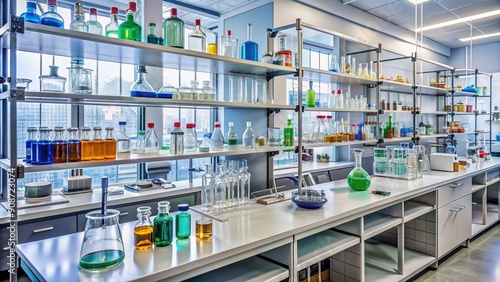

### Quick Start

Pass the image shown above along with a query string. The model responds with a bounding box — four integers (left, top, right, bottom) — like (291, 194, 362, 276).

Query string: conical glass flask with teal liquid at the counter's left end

(80, 209, 125, 271)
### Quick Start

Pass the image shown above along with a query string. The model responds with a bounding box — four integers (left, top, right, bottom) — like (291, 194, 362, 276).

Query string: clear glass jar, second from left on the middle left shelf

(67, 58, 92, 94)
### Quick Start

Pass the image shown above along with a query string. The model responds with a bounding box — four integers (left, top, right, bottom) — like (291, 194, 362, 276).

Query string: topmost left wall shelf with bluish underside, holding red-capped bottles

(1, 23, 297, 77)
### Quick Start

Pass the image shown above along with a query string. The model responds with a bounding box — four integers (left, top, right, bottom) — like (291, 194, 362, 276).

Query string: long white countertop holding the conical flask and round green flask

(17, 159, 500, 281)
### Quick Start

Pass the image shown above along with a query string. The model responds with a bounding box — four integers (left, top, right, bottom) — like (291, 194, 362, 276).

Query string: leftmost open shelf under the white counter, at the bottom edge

(185, 257, 289, 282)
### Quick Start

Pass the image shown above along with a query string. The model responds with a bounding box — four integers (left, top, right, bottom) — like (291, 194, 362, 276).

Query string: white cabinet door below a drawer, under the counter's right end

(437, 194, 472, 258)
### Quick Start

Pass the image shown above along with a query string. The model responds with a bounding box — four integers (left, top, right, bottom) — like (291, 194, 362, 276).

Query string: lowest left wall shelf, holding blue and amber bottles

(0, 146, 295, 172)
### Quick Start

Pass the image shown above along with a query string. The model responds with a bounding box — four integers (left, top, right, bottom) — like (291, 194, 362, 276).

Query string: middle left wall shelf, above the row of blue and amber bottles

(2, 91, 295, 110)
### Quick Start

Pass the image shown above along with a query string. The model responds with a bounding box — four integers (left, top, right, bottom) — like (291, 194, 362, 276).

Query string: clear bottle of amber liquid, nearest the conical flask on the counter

(134, 206, 154, 251)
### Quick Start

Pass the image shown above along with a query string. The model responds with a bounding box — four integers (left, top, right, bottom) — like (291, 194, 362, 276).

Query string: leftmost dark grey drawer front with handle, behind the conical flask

(18, 215, 76, 244)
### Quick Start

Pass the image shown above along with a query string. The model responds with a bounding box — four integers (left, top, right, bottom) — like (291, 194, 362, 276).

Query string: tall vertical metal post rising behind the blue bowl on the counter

(295, 18, 304, 193)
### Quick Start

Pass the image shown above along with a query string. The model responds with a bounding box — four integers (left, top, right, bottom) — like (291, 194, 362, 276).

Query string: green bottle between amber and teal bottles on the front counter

(153, 201, 174, 247)
